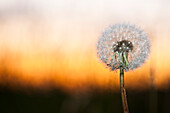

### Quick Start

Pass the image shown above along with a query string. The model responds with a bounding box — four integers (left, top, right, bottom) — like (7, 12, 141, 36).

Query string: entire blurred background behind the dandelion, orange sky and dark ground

(0, 0, 170, 113)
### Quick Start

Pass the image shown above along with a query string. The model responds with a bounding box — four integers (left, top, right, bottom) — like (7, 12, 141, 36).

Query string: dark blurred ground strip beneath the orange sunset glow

(0, 88, 170, 113)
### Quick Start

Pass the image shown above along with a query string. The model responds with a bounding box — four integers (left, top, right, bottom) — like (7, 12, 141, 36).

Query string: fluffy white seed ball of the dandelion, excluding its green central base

(97, 24, 151, 71)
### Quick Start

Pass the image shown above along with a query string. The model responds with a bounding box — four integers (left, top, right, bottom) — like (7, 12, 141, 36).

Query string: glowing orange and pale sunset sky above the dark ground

(0, 0, 170, 91)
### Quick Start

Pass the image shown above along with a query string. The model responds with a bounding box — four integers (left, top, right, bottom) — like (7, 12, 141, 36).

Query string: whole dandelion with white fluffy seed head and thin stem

(97, 24, 150, 113)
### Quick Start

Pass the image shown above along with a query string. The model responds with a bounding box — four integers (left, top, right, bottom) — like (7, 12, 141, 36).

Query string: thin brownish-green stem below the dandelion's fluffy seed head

(120, 67, 129, 113)
